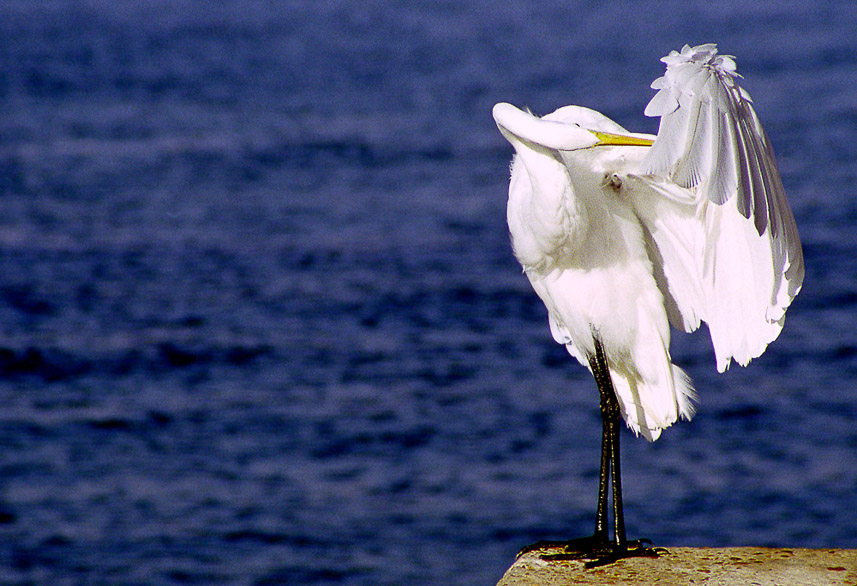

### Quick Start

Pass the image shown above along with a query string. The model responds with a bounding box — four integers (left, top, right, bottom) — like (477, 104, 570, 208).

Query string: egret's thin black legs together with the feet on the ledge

(518, 333, 664, 568)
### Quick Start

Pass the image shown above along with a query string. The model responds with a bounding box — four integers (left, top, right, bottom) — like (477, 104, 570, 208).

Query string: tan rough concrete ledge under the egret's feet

(497, 547, 857, 586)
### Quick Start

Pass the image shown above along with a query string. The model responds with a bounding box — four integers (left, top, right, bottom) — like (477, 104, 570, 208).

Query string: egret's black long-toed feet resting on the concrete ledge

(517, 536, 667, 568)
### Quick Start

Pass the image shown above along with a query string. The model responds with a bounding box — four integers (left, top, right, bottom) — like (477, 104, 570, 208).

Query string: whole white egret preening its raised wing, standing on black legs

(493, 44, 804, 566)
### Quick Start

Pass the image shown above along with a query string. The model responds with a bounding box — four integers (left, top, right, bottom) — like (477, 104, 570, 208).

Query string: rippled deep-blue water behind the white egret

(0, 0, 857, 584)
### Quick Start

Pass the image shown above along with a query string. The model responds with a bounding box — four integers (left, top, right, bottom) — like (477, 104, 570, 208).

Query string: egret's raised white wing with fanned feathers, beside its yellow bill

(633, 44, 803, 371)
